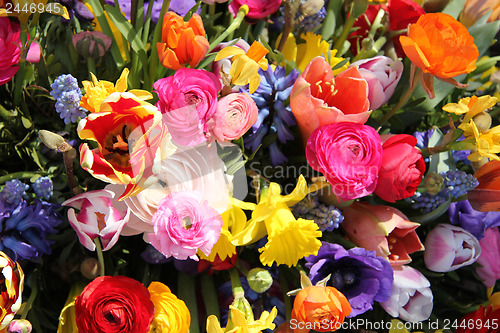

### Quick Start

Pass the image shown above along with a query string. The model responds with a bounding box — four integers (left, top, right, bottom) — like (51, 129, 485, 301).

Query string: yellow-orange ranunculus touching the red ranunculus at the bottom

(148, 281, 191, 333)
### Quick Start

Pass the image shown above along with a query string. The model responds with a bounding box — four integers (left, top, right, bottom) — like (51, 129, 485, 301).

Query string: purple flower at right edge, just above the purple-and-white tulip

(448, 200, 500, 239)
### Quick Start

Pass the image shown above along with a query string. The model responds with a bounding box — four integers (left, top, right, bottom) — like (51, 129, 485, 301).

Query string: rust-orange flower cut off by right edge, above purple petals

(467, 161, 500, 212)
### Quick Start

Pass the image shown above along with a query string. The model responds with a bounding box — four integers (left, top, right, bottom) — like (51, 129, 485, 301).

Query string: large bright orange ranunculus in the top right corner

(399, 13, 479, 95)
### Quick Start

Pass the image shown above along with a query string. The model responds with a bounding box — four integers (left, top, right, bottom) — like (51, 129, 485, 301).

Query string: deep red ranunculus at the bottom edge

(75, 276, 154, 333)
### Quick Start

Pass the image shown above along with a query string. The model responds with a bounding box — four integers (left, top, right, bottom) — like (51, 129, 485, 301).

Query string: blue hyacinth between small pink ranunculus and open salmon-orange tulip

(244, 66, 299, 165)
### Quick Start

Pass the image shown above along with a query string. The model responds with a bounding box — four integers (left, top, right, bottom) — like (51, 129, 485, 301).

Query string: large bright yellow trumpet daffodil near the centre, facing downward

(232, 175, 322, 266)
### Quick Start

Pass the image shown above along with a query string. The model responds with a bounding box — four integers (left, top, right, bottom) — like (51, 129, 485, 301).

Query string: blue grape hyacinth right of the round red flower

(411, 170, 479, 213)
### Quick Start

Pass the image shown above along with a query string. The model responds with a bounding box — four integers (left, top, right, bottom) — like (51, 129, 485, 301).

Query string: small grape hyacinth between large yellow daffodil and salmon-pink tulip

(292, 195, 344, 231)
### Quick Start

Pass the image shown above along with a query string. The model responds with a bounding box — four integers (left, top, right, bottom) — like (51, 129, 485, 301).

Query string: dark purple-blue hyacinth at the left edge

(0, 198, 61, 261)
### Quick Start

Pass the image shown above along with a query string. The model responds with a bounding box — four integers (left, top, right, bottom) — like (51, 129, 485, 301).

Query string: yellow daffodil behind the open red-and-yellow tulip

(80, 68, 153, 112)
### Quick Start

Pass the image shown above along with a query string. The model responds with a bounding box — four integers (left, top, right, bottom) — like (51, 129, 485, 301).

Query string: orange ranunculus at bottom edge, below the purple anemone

(290, 286, 351, 332)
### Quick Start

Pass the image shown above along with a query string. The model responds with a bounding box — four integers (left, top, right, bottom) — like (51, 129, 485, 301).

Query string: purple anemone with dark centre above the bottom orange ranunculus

(306, 242, 393, 318)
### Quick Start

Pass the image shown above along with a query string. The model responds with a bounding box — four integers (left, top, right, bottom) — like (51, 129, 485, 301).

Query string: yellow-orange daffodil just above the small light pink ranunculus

(215, 41, 269, 94)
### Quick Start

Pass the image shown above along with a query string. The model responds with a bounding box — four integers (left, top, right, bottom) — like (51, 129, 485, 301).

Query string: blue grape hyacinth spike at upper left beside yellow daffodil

(50, 74, 85, 124)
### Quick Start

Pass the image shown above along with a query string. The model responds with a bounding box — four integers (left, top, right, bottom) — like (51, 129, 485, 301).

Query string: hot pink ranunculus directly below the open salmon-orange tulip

(306, 122, 382, 200)
